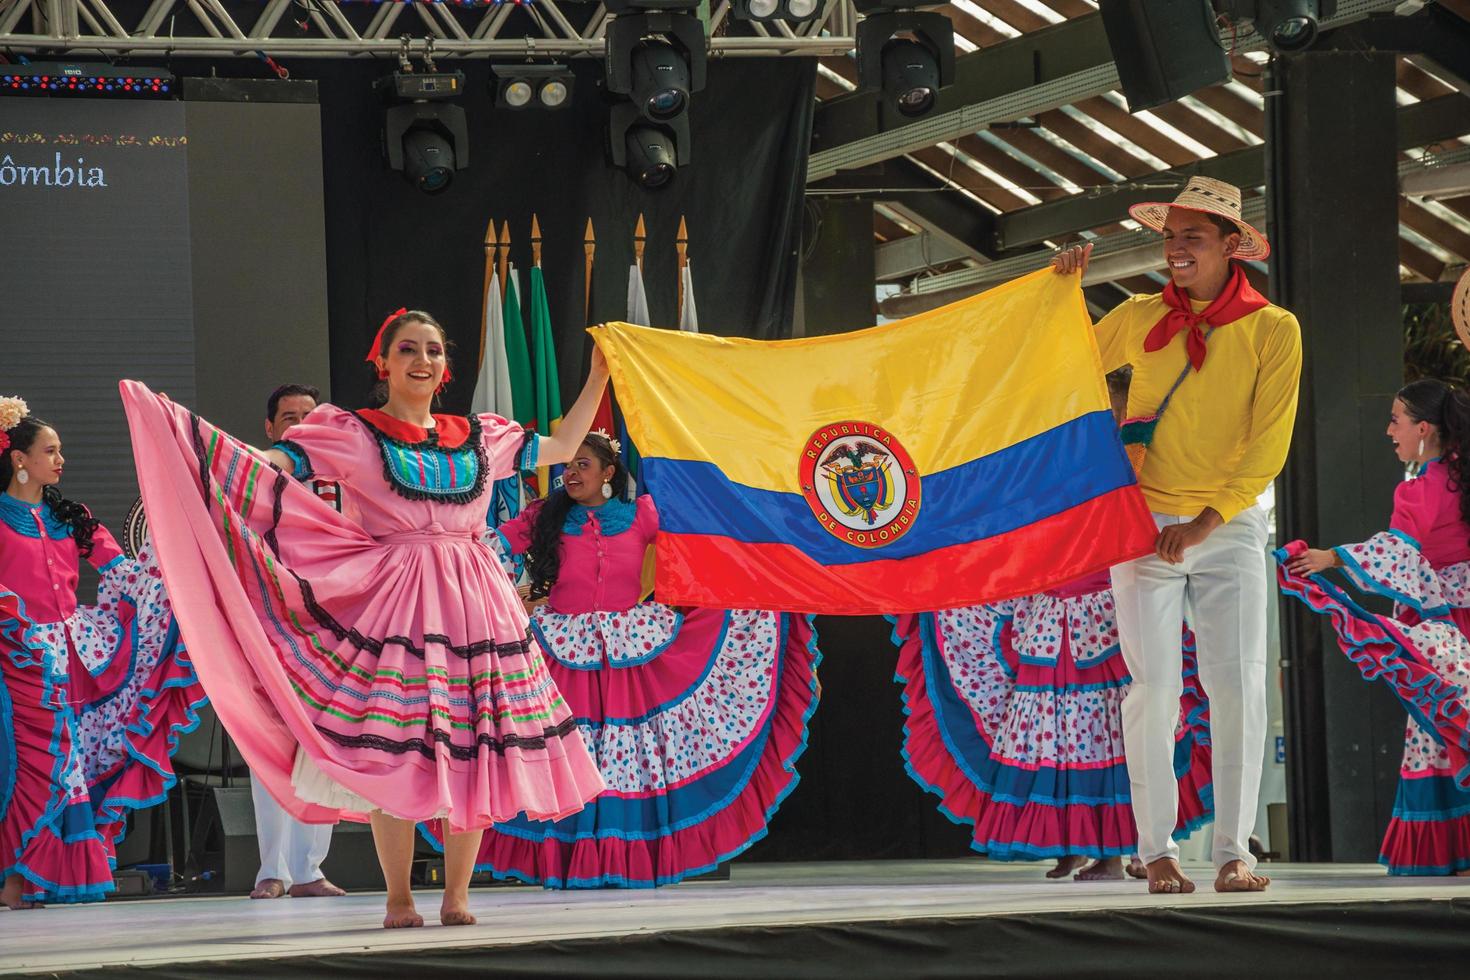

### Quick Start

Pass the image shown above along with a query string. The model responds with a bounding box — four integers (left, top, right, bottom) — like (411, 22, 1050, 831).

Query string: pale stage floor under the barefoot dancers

(0, 860, 1470, 976)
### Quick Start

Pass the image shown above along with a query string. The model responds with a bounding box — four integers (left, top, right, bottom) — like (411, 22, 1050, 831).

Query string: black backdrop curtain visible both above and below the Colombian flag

(173, 59, 969, 861)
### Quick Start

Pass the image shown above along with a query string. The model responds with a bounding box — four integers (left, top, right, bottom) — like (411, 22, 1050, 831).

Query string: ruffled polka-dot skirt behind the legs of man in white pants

(894, 572, 1213, 861)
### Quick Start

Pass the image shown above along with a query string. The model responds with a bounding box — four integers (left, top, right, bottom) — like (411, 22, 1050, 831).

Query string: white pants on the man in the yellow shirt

(1113, 507, 1267, 868)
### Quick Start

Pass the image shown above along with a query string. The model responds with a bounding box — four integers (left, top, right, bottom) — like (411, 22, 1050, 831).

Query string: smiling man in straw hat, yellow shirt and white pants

(1054, 176, 1301, 892)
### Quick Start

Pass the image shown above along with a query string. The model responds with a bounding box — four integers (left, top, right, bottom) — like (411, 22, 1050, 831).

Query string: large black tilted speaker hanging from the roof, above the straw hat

(1098, 0, 1230, 112)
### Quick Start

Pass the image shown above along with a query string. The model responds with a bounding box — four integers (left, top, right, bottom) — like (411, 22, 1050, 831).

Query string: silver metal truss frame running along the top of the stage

(0, 0, 858, 59)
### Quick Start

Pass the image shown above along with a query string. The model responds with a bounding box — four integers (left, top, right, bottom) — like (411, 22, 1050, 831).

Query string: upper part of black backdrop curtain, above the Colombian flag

(307, 59, 816, 410)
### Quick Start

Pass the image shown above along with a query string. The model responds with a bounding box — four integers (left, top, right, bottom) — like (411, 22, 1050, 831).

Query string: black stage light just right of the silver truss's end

(857, 10, 954, 118)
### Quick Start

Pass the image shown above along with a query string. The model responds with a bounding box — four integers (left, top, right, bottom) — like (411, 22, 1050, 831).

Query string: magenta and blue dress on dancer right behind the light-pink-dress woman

(431, 497, 820, 887)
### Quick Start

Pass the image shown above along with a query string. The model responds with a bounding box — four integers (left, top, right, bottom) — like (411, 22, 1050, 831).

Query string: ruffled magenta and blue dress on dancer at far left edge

(0, 494, 206, 902)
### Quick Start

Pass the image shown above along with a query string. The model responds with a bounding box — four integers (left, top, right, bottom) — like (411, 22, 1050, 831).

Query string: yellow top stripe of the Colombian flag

(589, 269, 1108, 494)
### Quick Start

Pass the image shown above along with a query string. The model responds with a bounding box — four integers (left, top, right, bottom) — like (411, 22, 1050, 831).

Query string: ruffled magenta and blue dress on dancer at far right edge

(1277, 460, 1470, 874)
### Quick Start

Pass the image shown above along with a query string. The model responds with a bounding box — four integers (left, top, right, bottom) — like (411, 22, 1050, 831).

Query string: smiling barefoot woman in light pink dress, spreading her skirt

(122, 310, 607, 929)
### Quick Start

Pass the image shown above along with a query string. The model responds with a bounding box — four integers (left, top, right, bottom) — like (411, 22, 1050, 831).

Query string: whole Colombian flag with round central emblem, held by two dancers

(591, 269, 1157, 616)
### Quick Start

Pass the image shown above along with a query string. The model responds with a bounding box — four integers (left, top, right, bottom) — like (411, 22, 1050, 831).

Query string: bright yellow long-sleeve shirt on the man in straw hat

(1097, 295, 1301, 520)
